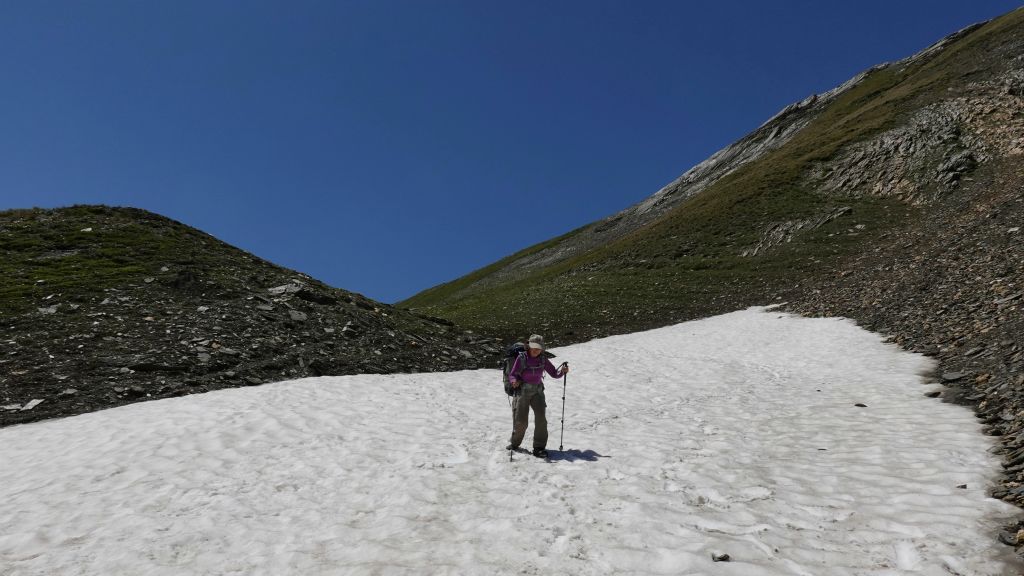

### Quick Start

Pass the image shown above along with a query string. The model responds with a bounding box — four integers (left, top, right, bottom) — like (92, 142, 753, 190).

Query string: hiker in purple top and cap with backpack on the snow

(505, 334, 569, 458)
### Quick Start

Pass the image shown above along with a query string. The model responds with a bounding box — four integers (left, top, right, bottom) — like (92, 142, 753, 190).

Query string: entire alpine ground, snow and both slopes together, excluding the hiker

(0, 4, 1024, 576)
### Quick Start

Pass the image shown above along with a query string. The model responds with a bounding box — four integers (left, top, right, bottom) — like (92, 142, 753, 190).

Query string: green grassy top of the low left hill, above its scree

(0, 206, 403, 323)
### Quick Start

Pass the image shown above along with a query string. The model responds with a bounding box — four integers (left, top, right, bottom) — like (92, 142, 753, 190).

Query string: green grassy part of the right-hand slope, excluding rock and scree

(399, 9, 1024, 341)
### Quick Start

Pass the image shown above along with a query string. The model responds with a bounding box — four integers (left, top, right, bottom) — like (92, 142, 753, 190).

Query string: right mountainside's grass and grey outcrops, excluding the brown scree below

(399, 10, 1024, 341)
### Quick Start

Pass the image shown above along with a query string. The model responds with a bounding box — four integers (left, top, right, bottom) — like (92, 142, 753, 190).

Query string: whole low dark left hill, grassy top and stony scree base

(0, 206, 498, 425)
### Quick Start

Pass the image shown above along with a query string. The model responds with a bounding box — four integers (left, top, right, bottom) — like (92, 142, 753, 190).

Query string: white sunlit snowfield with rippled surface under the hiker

(0, 308, 1022, 576)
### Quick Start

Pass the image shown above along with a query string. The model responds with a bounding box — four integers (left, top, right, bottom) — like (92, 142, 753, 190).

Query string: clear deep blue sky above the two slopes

(0, 0, 1020, 302)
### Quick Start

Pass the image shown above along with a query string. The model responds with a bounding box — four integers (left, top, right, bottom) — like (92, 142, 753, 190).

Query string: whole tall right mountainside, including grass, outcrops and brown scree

(399, 9, 1024, 510)
